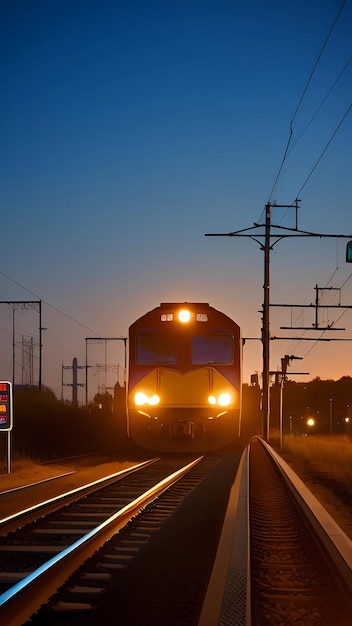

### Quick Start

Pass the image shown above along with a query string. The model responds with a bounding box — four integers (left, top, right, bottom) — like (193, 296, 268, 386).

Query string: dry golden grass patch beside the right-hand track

(283, 435, 352, 493)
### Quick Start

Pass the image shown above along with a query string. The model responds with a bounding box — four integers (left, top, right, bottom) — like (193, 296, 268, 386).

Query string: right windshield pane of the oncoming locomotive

(192, 335, 233, 365)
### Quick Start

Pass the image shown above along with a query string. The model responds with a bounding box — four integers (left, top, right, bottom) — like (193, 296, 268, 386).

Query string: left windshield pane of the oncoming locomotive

(136, 333, 177, 364)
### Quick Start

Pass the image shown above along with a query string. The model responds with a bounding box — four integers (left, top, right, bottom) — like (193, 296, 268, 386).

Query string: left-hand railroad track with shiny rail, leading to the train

(0, 457, 219, 626)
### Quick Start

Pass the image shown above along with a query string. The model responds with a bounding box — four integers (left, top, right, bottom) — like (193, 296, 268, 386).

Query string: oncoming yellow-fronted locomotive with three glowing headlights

(126, 302, 242, 453)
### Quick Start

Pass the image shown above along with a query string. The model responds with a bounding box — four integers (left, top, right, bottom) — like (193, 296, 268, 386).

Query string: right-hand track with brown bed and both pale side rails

(199, 438, 352, 626)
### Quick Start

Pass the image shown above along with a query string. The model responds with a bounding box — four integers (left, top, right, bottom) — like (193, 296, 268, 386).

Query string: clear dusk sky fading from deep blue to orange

(0, 0, 352, 399)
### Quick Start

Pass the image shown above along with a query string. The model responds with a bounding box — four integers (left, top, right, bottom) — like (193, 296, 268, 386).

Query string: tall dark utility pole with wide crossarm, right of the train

(205, 204, 352, 440)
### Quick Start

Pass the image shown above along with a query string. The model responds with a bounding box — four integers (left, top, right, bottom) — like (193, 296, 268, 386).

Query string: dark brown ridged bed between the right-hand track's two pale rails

(249, 440, 352, 626)
